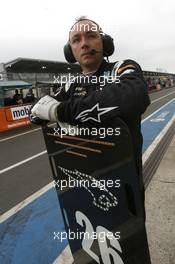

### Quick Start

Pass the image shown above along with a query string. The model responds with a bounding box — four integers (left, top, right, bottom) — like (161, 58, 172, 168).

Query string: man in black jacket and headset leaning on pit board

(31, 17, 150, 193)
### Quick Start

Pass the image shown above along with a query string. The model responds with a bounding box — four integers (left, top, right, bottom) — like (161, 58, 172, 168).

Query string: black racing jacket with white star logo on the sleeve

(55, 60, 150, 187)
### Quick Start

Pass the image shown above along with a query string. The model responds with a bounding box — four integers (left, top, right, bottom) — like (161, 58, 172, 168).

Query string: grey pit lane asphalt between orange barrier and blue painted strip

(0, 88, 175, 214)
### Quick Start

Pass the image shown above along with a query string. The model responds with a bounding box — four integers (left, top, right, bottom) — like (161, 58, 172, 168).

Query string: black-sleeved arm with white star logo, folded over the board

(57, 60, 150, 125)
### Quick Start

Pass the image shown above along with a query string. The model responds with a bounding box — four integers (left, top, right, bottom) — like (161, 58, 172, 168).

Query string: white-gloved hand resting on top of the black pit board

(30, 95, 60, 123)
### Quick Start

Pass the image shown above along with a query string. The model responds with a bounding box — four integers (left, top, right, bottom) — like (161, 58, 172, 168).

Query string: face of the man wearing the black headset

(69, 20, 103, 67)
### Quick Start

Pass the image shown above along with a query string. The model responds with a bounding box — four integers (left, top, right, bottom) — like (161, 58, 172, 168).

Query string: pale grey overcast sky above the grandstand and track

(0, 0, 175, 73)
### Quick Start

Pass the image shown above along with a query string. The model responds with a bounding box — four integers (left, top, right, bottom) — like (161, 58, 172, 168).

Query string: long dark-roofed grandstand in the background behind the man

(0, 58, 175, 90)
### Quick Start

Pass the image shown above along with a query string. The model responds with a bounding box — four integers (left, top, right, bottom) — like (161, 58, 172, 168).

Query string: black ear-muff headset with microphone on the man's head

(64, 18, 114, 63)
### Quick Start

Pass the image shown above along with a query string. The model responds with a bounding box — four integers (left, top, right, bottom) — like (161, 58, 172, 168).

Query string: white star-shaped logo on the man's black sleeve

(75, 103, 118, 123)
